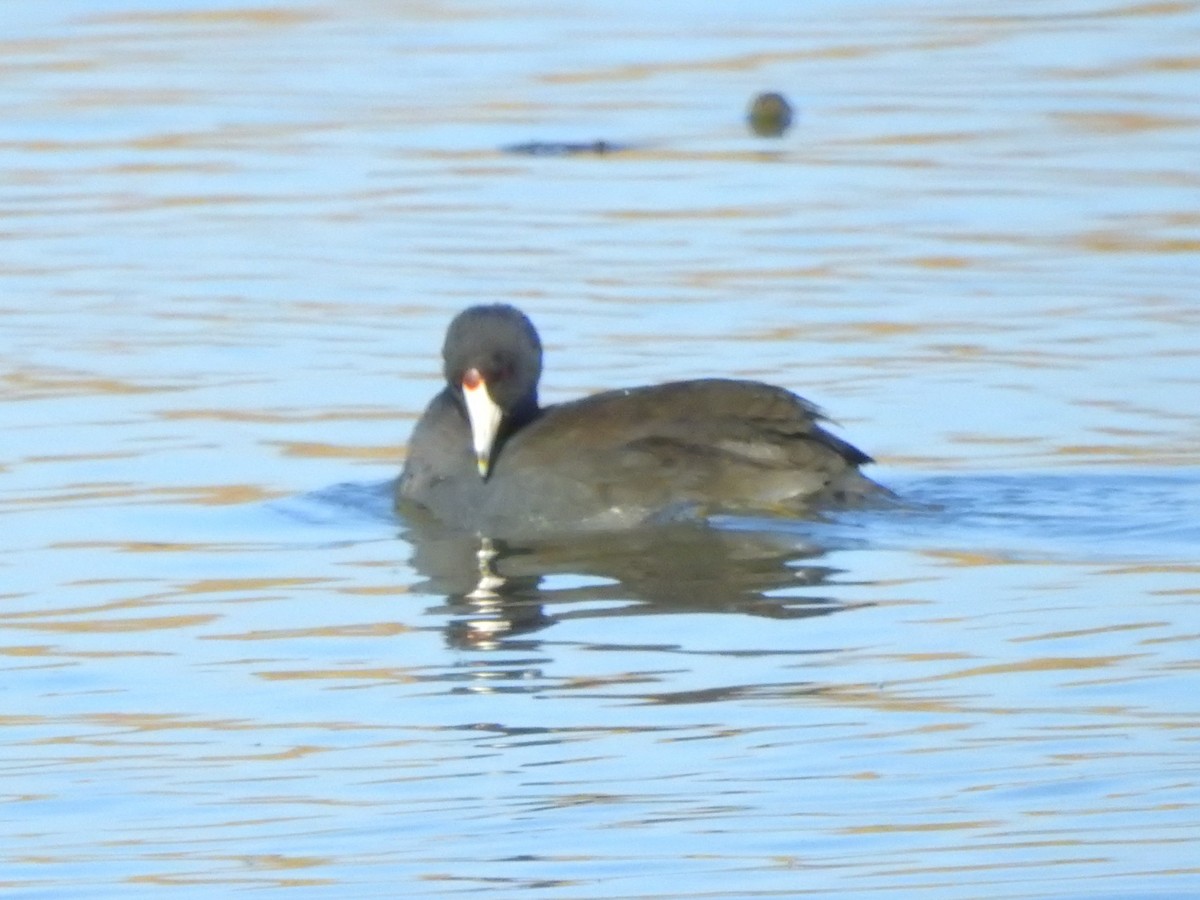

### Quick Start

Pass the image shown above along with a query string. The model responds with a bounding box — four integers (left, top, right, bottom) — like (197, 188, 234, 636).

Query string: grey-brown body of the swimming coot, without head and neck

(402, 379, 881, 534)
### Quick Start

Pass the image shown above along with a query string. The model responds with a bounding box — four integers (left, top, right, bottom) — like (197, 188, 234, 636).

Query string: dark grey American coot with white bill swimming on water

(396, 304, 886, 536)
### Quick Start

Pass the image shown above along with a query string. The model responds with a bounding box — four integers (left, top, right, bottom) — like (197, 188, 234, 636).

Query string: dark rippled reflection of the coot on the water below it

(403, 516, 860, 650)
